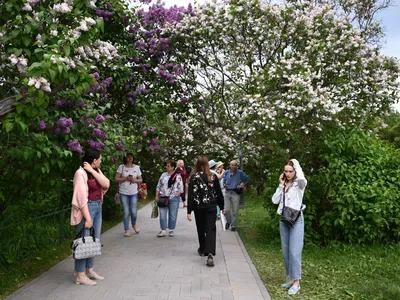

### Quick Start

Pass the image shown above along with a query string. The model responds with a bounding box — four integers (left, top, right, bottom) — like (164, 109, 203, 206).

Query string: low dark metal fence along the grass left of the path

(0, 206, 74, 265)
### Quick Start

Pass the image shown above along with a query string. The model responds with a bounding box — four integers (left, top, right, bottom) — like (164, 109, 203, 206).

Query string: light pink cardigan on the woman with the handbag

(71, 167, 107, 225)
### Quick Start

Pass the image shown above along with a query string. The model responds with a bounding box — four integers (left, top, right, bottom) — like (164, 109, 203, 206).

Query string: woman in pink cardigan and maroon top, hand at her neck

(71, 149, 110, 285)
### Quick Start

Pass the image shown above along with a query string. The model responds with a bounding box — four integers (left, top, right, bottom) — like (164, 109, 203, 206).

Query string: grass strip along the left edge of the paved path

(0, 197, 151, 299)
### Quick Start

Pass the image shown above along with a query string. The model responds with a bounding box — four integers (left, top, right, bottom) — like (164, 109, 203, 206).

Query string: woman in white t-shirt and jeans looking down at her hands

(114, 152, 143, 237)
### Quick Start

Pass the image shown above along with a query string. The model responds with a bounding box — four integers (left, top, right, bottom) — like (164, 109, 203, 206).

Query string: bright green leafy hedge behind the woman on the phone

(266, 130, 400, 244)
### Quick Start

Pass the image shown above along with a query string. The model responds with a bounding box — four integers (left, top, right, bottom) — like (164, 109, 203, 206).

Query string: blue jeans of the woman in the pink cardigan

(75, 200, 103, 272)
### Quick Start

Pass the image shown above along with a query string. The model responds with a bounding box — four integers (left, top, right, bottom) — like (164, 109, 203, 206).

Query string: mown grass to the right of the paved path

(238, 195, 400, 300)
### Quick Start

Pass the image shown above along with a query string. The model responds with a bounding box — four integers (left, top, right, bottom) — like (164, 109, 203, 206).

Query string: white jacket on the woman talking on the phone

(272, 162, 307, 215)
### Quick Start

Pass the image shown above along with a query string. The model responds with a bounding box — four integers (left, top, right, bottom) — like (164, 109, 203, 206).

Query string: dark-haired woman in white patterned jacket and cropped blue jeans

(155, 160, 183, 237)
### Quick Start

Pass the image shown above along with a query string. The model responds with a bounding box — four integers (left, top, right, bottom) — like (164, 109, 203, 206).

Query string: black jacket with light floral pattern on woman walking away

(187, 173, 224, 214)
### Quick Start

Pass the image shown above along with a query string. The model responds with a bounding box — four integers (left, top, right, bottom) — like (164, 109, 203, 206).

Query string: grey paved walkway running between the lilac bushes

(6, 205, 270, 300)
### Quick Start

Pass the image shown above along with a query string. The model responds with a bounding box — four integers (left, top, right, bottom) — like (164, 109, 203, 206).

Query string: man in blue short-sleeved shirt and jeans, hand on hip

(224, 160, 250, 231)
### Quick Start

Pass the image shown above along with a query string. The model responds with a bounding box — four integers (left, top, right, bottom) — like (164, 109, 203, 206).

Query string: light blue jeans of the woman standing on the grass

(279, 212, 304, 280)
